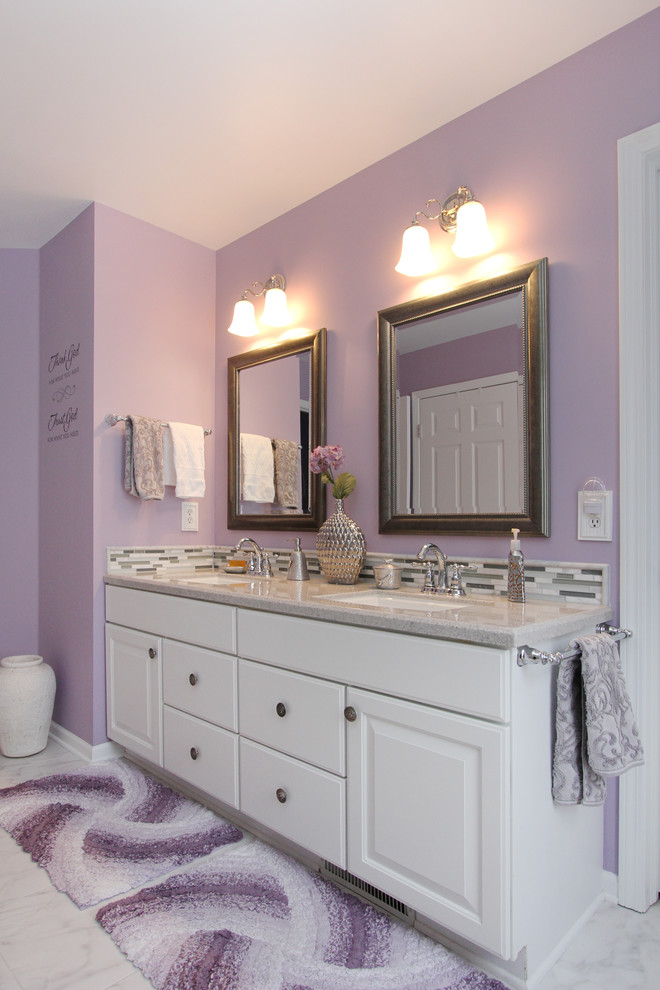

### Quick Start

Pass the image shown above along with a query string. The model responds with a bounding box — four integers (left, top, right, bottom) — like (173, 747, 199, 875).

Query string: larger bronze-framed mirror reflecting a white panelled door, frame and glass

(378, 258, 550, 536)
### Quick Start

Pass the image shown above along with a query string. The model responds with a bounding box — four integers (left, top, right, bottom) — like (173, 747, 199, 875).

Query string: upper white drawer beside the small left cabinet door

(163, 639, 237, 732)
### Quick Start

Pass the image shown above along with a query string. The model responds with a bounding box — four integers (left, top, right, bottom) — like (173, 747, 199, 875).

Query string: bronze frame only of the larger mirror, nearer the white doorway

(378, 258, 550, 536)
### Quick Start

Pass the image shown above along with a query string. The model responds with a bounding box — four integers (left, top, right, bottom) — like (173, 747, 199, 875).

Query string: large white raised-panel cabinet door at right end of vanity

(347, 690, 510, 957)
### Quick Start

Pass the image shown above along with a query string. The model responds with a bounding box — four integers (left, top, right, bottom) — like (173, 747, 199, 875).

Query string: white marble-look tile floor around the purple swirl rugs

(0, 741, 660, 990)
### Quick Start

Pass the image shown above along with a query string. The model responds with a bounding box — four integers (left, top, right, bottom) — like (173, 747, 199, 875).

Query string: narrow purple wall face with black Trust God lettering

(38, 207, 94, 741)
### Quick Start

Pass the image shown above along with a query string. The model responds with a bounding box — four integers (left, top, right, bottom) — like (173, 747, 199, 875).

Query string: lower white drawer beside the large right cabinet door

(240, 739, 346, 868)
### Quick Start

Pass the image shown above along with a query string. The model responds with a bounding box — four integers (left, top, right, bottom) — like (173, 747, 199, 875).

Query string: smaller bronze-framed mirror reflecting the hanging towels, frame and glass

(227, 329, 326, 530)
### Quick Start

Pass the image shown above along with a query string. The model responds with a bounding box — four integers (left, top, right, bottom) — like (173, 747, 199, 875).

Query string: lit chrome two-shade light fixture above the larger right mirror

(396, 186, 495, 276)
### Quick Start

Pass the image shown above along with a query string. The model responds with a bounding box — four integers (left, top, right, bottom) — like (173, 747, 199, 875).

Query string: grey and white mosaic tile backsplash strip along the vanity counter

(106, 546, 610, 605)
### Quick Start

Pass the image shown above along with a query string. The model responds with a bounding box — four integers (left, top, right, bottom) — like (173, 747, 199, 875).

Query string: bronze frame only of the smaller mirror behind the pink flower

(227, 328, 326, 530)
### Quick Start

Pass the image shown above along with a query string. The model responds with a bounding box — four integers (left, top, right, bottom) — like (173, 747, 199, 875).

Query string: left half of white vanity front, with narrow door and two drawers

(106, 587, 239, 808)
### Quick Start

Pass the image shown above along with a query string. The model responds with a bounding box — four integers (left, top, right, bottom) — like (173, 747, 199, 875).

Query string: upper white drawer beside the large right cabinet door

(238, 660, 346, 776)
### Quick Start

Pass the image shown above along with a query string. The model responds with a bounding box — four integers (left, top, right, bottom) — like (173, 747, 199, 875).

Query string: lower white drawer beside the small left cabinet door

(163, 706, 238, 808)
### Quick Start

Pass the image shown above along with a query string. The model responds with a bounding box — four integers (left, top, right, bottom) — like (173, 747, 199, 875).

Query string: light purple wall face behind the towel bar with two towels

(93, 205, 215, 743)
